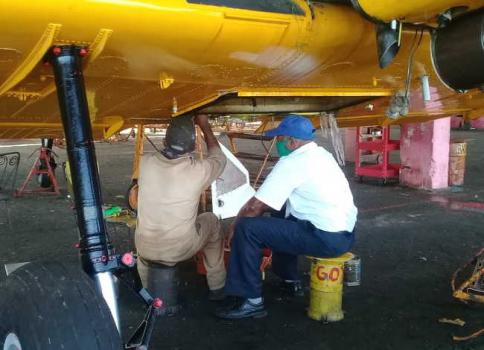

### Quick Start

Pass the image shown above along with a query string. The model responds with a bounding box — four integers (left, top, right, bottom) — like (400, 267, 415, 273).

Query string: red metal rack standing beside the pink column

(355, 126, 400, 180)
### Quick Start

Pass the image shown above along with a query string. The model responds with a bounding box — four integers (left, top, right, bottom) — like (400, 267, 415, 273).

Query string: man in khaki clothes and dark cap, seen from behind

(135, 115, 226, 306)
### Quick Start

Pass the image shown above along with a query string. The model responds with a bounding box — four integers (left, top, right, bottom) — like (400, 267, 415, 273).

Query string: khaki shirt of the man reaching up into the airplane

(135, 147, 226, 263)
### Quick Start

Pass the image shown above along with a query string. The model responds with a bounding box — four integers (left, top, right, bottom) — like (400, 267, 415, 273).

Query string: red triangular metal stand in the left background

(15, 147, 61, 197)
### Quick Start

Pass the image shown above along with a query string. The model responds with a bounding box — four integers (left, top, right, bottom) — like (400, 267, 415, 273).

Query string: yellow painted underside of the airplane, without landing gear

(0, 0, 484, 138)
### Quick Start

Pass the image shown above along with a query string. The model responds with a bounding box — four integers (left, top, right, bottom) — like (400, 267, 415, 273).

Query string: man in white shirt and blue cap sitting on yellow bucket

(217, 115, 357, 319)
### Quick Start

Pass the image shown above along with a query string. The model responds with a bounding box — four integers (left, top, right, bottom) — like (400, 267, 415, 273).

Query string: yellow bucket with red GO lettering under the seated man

(308, 253, 354, 322)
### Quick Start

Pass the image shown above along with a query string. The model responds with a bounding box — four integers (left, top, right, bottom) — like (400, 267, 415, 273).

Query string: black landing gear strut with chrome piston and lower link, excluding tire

(50, 45, 162, 350)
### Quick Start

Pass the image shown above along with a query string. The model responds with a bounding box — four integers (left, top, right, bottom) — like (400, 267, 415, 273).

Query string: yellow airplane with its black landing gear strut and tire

(0, 0, 484, 349)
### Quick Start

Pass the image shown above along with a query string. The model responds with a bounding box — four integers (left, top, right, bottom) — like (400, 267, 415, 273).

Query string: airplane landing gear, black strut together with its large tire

(0, 45, 163, 350)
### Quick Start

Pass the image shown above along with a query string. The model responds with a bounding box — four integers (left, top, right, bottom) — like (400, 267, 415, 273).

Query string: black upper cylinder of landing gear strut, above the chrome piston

(47, 45, 115, 275)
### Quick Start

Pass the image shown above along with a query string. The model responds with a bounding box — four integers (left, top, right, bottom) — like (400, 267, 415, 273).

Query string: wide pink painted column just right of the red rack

(400, 118, 450, 190)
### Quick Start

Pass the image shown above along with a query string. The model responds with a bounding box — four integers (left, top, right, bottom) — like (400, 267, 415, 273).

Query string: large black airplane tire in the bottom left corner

(0, 262, 121, 350)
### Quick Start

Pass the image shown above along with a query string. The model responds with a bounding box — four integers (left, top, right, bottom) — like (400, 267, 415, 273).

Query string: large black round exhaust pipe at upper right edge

(432, 8, 484, 91)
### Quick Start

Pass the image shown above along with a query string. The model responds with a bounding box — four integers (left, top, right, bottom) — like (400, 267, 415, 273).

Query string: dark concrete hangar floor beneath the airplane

(0, 131, 484, 349)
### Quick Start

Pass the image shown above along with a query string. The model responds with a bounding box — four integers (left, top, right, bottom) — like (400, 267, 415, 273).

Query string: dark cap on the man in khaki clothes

(165, 115, 195, 154)
